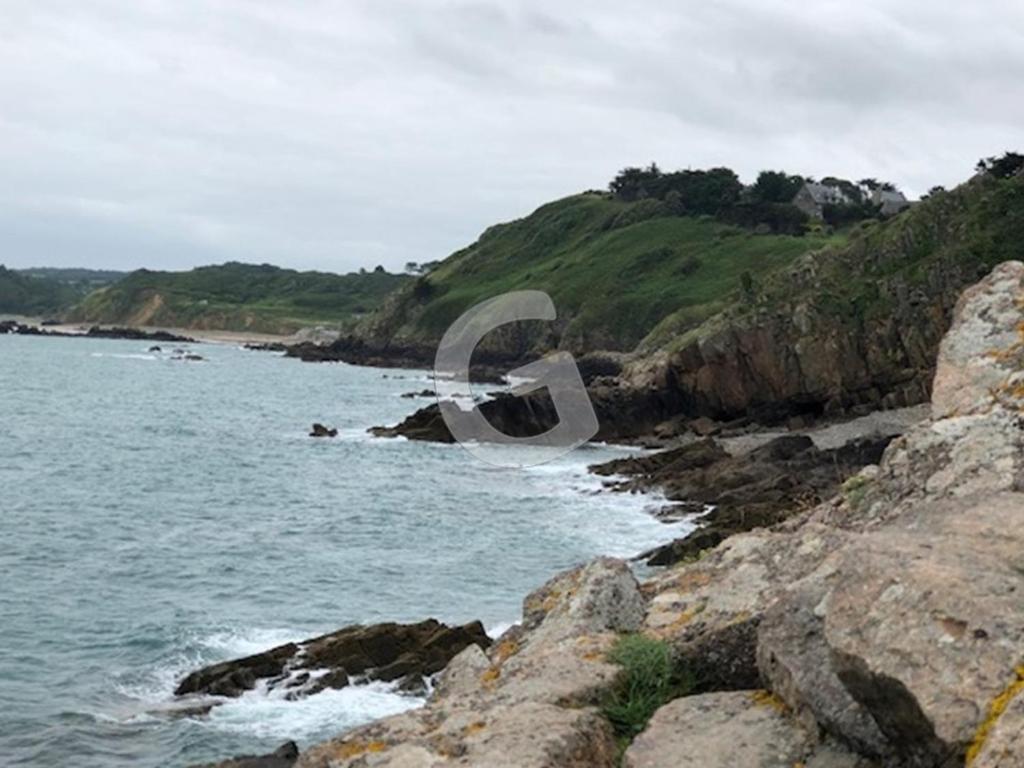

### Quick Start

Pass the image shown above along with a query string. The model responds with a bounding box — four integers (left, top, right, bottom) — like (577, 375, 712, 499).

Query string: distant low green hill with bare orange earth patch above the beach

(70, 263, 410, 333)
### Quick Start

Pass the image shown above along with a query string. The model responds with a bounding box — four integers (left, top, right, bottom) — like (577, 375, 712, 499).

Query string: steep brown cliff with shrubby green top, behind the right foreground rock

(624, 176, 1024, 419)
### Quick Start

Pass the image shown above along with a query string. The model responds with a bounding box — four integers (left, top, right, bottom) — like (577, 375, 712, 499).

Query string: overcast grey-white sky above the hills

(0, 0, 1024, 272)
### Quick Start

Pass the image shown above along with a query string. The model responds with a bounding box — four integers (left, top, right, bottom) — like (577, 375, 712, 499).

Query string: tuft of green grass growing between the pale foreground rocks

(601, 635, 693, 744)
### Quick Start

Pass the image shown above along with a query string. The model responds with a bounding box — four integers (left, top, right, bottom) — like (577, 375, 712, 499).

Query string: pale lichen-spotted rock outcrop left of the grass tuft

(296, 558, 644, 768)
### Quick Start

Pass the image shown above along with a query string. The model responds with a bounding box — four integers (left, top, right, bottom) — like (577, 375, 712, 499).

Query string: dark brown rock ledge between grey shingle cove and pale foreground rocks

(591, 435, 892, 565)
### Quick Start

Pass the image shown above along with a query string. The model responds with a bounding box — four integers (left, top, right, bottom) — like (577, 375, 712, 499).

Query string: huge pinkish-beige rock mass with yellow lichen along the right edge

(745, 264, 1024, 766)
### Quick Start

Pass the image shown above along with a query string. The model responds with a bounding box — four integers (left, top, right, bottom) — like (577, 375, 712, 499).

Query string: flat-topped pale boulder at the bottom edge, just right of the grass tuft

(623, 690, 814, 768)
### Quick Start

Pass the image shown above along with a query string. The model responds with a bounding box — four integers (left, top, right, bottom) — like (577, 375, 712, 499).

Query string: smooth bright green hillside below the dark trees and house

(364, 194, 842, 350)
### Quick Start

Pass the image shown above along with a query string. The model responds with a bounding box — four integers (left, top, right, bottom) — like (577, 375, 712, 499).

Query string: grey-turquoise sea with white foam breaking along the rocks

(0, 336, 677, 768)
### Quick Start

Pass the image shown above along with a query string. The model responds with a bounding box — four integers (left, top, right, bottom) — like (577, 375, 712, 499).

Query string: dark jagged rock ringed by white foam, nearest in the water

(174, 618, 490, 698)
